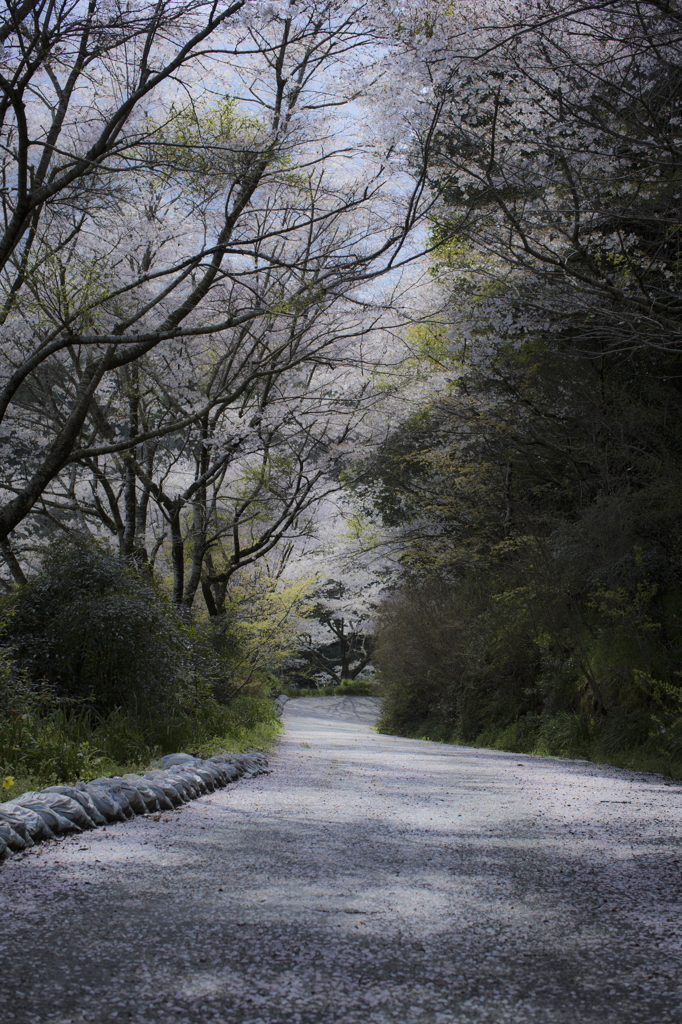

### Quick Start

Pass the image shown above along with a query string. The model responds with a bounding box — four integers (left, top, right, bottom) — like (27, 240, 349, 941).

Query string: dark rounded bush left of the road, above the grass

(6, 535, 191, 714)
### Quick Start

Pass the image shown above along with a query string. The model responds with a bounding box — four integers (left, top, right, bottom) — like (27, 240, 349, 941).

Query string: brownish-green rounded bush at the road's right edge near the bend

(374, 581, 538, 742)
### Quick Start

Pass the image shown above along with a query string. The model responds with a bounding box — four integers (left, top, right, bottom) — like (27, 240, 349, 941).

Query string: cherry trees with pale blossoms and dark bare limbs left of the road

(0, 0, 436, 577)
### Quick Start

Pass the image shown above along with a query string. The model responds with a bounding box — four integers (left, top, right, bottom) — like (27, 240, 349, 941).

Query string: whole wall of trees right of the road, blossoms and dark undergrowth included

(361, 2, 682, 771)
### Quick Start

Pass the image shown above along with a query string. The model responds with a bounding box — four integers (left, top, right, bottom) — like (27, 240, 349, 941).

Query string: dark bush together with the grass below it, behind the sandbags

(0, 536, 280, 786)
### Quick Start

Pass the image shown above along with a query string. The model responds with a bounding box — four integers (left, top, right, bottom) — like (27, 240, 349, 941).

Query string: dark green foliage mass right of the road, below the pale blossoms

(368, 342, 682, 771)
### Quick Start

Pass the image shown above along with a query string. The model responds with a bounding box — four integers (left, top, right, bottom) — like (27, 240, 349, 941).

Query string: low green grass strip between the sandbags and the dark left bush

(0, 696, 282, 801)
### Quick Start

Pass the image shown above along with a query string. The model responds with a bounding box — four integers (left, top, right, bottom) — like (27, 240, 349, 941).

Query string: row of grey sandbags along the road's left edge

(0, 754, 268, 861)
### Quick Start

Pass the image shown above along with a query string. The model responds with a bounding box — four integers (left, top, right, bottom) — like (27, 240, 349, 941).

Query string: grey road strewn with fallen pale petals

(0, 697, 682, 1024)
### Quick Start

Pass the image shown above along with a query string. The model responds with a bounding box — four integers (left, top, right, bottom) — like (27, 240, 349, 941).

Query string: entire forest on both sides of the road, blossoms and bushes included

(0, 0, 682, 793)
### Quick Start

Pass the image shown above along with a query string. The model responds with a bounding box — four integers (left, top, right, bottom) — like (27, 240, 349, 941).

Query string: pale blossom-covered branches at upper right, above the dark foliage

(387, 0, 682, 355)
